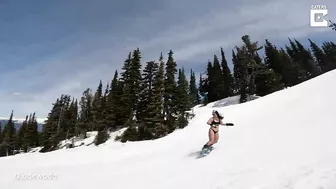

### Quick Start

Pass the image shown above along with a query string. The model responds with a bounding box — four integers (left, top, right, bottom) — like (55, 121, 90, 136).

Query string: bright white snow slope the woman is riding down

(0, 71, 336, 189)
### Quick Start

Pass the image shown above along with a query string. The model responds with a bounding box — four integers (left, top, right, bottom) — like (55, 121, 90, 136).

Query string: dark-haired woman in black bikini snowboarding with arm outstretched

(202, 110, 233, 150)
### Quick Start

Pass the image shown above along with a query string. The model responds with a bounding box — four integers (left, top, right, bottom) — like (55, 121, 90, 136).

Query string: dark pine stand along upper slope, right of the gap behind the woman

(199, 35, 336, 103)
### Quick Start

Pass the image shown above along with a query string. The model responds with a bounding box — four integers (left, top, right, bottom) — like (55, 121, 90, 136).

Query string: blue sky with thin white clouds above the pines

(0, 0, 336, 118)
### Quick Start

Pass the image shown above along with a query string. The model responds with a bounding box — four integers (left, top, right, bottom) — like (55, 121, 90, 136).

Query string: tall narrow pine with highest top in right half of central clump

(164, 50, 177, 132)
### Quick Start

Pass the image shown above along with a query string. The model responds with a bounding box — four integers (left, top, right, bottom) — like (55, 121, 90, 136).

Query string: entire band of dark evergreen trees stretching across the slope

(0, 31, 336, 156)
